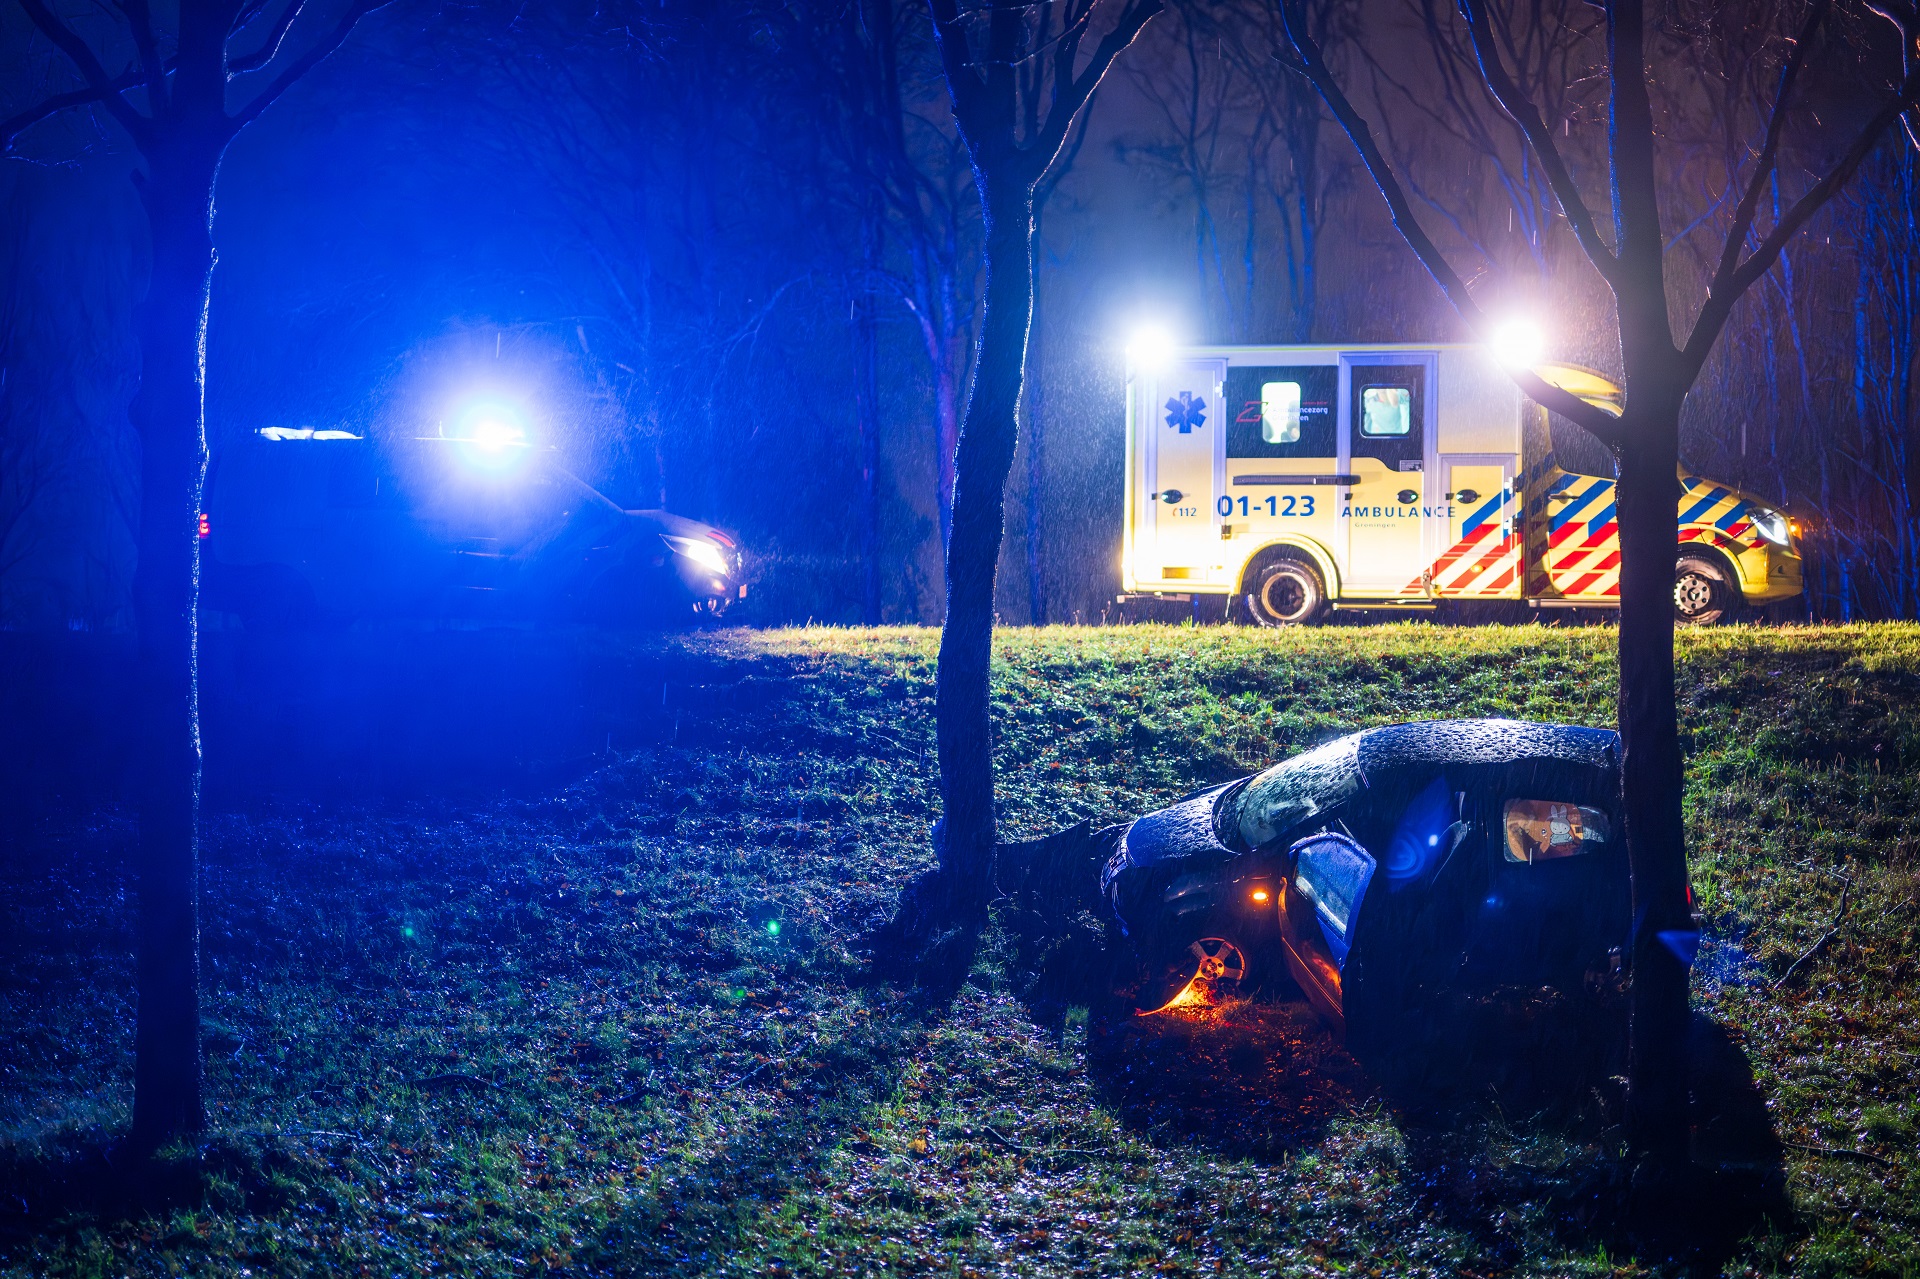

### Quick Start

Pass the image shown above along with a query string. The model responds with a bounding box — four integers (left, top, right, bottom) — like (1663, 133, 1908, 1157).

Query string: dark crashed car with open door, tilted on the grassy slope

(1100, 718, 1630, 1037)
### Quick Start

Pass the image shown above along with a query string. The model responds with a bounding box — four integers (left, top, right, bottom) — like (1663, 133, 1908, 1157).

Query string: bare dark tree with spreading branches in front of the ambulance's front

(1281, 0, 1920, 1168)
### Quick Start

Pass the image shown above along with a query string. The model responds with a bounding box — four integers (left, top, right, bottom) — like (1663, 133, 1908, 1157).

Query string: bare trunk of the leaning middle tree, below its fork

(935, 173, 1033, 918)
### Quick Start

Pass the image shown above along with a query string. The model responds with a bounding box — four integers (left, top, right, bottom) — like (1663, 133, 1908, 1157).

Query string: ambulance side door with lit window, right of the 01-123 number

(1340, 353, 1434, 599)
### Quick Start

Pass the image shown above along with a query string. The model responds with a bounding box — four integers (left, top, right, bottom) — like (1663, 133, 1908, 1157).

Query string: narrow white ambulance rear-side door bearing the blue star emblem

(1140, 359, 1227, 584)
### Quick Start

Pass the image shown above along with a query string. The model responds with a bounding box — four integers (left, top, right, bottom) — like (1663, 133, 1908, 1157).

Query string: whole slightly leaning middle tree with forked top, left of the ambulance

(895, 0, 1162, 945)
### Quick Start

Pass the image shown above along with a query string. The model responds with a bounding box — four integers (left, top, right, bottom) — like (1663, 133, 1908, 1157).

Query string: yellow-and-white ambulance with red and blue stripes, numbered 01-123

(1117, 346, 1801, 626)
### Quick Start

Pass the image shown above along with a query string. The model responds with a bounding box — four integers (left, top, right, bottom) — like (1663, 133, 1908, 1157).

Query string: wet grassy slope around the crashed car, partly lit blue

(0, 624, 1920, 1275)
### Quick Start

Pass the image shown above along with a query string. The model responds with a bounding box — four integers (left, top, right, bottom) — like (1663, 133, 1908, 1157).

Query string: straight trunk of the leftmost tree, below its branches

(129, 138, 225, 1148)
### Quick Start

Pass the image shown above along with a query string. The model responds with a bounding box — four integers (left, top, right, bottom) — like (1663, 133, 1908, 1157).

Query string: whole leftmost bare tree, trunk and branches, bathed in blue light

(0, 0, 386, 1148)
